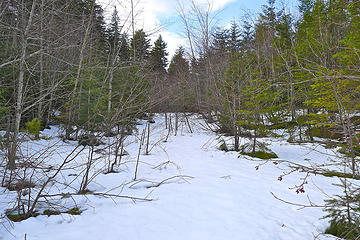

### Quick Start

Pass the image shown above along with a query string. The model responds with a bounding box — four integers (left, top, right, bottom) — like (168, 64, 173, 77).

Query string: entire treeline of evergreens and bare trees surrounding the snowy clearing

(0, 0, 360, 236)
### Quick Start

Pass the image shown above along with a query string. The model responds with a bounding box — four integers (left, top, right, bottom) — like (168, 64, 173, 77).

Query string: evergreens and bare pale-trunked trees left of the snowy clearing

(0, 0, 172, 168)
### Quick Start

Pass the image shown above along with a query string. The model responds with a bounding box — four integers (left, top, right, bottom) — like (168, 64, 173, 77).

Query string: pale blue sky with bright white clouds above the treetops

(99, 0, 296, 56)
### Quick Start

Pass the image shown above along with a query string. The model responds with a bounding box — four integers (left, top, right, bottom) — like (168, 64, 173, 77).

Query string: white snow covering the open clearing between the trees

(0, 116, 346, 240)
